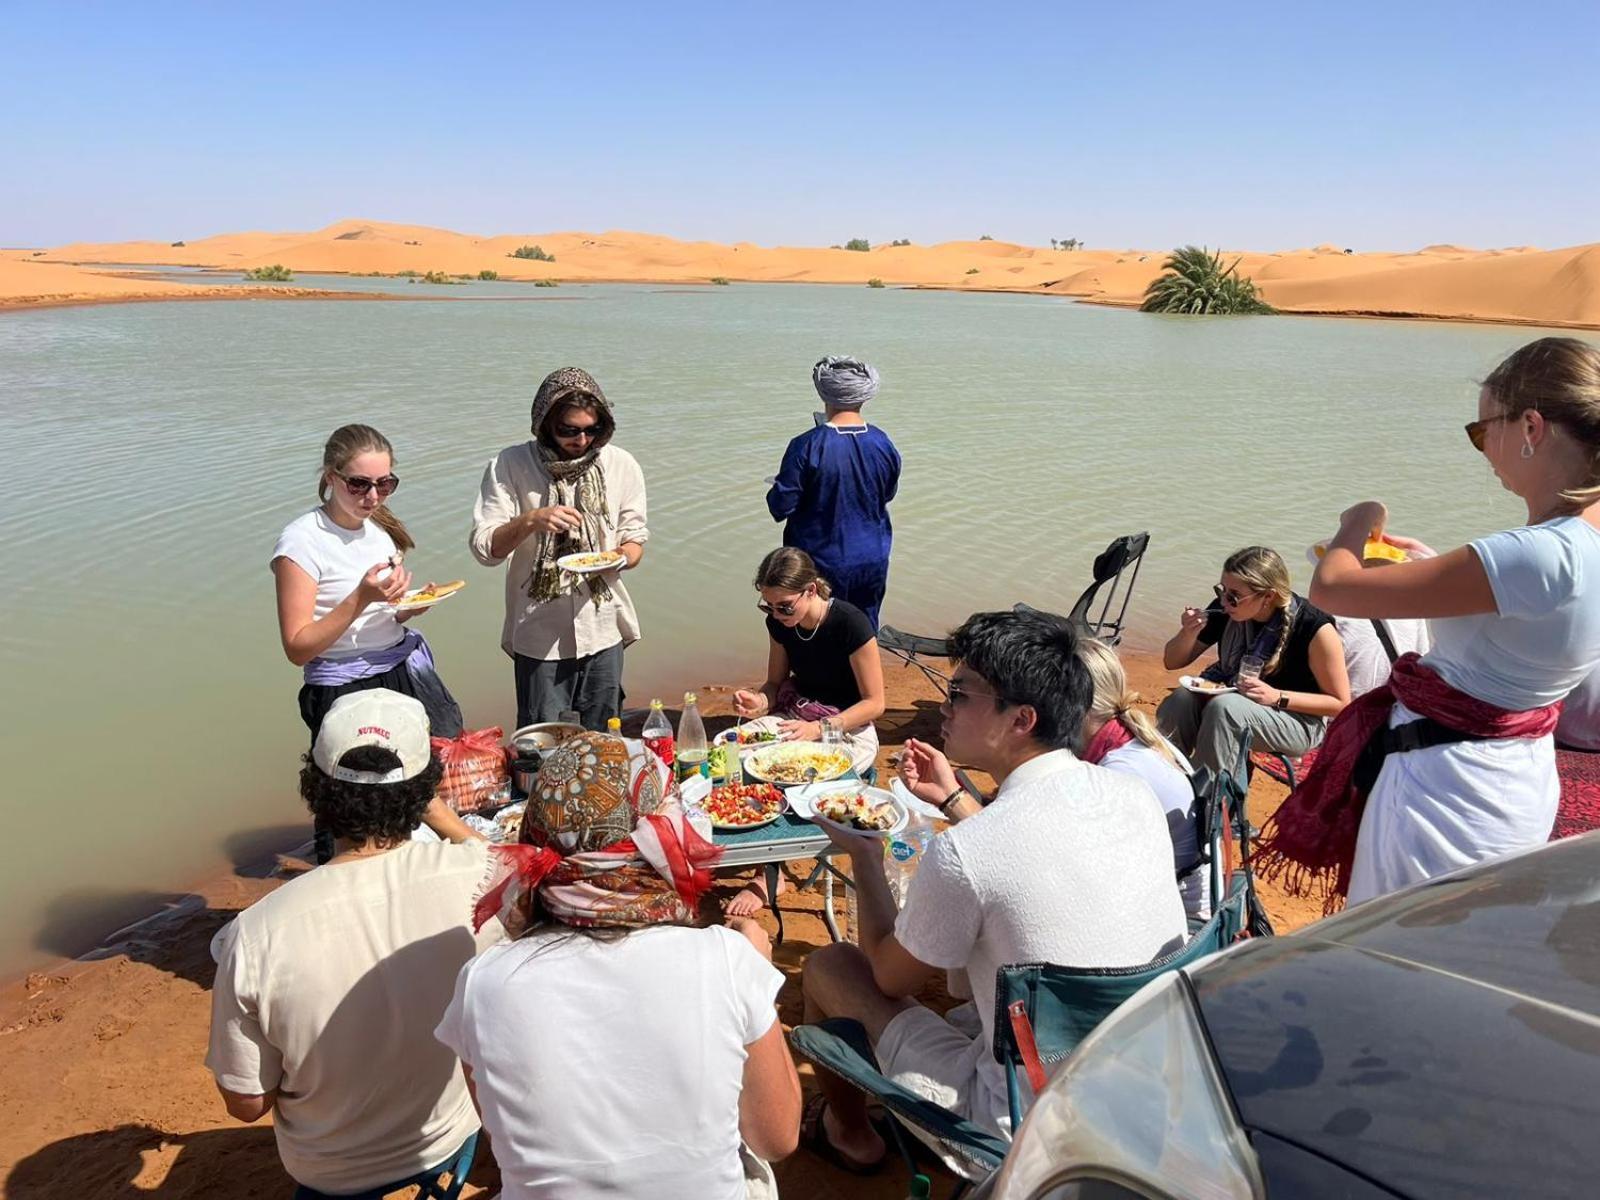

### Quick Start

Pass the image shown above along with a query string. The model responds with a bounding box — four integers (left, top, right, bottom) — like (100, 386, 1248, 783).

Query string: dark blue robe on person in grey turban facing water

(766, 426, 901, 629)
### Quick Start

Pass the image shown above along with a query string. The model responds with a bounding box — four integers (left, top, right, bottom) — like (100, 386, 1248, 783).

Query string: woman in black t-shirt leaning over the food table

(728, 546, 883, 917)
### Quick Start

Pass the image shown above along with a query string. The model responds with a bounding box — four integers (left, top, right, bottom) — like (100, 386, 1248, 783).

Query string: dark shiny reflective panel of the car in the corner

(1190, 834, 1600, 1197)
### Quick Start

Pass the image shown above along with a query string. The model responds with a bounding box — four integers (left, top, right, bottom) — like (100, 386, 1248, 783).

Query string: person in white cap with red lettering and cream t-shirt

(206, 688, 496, 1197)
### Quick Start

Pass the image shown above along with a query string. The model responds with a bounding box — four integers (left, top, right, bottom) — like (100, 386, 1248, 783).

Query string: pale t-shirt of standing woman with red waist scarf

(1424, 517, 1600, 712)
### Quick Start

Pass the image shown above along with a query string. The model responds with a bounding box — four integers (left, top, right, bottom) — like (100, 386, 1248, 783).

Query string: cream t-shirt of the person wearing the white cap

(206, 842, 501, 1194)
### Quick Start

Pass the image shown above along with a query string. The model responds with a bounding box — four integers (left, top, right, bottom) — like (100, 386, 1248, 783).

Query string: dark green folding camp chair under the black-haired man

(789, 886, 1245, 1197)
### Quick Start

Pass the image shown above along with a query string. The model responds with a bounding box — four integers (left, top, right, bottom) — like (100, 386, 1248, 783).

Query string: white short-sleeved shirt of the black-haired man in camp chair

(894, 750, 1189, 1130)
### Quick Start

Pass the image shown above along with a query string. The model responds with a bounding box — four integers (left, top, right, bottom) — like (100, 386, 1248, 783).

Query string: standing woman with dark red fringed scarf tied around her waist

(1267, 338, 1600, 907)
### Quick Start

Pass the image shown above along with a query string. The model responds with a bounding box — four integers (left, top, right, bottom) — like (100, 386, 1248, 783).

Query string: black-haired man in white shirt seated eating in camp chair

(802, 611, 1187, 1171)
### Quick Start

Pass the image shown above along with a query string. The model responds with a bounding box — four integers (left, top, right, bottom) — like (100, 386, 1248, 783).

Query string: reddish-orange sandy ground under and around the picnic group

(0, 656, 1320, 1200)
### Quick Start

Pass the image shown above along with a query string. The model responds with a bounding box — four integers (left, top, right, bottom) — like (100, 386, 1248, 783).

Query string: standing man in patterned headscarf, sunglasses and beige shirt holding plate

(470, 366, 650, 730)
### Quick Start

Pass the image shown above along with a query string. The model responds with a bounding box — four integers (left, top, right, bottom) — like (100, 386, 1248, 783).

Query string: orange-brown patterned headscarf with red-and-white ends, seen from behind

(472, 733, 722, 938)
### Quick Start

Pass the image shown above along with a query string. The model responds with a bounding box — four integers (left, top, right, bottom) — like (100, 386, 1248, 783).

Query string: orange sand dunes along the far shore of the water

(0, 221, 1600, 328)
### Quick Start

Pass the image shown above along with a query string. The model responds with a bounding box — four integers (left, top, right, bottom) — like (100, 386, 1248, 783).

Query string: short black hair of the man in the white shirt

(949, 611, 1094, 750)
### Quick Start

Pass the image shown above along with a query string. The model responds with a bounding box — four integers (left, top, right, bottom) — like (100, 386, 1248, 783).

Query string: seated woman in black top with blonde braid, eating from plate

(1155, 546, 1350, 771)
